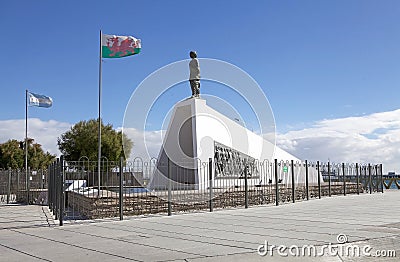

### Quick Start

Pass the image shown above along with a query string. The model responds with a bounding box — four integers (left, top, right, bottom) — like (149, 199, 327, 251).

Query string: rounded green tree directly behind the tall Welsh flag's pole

(58, 119, 133, 161)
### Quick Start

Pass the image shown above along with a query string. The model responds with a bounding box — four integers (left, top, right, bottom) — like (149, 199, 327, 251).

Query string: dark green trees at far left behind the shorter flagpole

(0, 138, 56, 170)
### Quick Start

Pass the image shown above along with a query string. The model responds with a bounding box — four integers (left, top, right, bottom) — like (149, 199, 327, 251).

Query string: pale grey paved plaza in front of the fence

(0, 190, 400, 262)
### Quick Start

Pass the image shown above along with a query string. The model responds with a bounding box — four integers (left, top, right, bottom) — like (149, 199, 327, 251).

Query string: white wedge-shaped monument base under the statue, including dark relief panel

(149, 98, 323, 190)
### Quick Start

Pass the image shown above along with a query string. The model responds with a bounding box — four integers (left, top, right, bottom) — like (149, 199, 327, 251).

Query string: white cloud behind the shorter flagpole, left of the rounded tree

(0, 118, 72, 156)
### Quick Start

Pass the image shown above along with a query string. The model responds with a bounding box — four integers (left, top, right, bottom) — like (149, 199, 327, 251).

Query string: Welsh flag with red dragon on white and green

(101, 34, 142, 58)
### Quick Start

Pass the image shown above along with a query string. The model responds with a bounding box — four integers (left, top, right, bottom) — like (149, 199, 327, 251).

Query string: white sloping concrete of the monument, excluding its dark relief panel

(149, 98, 323, 189)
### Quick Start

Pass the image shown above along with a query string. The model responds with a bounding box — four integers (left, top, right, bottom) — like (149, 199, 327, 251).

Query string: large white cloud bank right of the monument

(276, 109, 400, 172)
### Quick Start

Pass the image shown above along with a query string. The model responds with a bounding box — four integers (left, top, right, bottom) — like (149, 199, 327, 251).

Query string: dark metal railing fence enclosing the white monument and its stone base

(48, 157, 384, 225)
